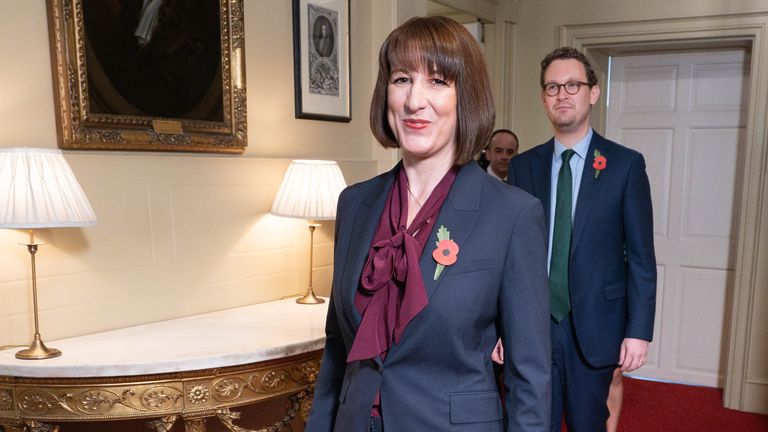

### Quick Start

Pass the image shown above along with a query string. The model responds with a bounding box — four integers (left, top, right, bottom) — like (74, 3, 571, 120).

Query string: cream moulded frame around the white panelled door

(560, 13, 768, 411)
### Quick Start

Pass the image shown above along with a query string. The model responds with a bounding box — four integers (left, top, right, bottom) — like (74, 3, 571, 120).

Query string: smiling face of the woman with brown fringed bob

(387, 67, 457, 161)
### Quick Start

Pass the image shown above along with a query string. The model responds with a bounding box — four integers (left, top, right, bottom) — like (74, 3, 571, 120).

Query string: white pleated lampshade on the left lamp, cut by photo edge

(0, 147, 96, 228)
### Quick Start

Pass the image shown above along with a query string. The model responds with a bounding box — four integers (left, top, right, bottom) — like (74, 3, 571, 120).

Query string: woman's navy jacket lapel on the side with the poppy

(419, 163, 488, 298)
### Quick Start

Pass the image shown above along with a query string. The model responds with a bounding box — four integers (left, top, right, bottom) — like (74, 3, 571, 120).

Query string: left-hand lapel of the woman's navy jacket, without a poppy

(341, 164, 400, 329)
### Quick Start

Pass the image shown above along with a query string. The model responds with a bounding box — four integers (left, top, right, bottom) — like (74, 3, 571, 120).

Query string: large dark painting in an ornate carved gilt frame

(47, 0, 247, 153)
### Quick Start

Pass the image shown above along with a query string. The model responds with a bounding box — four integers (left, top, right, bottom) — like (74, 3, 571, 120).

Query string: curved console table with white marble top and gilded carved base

(0, 299, 328, 432)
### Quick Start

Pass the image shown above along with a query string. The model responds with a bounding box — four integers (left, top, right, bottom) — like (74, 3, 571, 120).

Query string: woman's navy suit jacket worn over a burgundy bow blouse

(306, 163, 551, 432)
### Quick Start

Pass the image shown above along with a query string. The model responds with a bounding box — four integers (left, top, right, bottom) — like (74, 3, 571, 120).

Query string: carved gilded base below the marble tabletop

(0, 351, 321, 432)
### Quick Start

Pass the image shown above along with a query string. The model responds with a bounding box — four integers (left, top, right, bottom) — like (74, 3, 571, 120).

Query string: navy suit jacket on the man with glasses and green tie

(507, 132, 656, 367)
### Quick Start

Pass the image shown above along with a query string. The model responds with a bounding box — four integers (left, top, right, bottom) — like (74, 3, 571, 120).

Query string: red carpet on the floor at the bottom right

(619, 377, 768, 432)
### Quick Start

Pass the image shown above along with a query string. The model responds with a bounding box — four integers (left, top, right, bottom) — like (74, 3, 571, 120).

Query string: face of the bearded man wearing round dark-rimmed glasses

(541, 59, 600, 133)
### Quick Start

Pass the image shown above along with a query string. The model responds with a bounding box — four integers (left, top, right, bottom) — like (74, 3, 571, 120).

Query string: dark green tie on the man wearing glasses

(549, 149, 575, 322)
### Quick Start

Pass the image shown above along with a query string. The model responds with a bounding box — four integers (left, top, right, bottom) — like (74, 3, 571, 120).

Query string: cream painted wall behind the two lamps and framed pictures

(0, 0, 384, 345)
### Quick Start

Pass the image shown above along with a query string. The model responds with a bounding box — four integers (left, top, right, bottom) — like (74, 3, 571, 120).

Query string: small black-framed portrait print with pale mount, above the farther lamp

(293, 0, 351, 122)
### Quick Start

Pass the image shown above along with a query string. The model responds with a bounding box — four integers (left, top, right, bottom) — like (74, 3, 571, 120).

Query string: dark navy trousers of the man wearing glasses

(549, 313, 618, 432)
